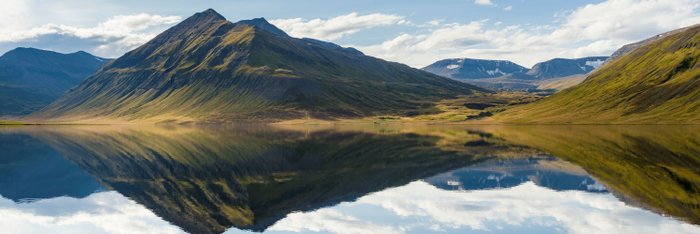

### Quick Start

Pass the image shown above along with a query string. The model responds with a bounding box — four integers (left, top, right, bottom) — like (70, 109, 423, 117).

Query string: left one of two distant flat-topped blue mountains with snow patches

(423, 58, 527, 79)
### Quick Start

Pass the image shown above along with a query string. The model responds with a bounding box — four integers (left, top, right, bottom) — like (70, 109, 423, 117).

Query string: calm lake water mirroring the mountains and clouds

(0, 125, 700, 234)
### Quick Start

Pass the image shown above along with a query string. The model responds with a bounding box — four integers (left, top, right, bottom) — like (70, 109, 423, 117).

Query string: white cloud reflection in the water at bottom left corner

(0, 192, 184, 234)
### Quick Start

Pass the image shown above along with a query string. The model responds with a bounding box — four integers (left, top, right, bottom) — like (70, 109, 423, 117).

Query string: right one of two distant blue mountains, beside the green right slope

(527, 56, 608, 80)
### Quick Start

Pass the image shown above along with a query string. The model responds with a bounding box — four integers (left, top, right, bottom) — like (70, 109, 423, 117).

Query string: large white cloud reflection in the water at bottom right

(270, 181, 700, 234)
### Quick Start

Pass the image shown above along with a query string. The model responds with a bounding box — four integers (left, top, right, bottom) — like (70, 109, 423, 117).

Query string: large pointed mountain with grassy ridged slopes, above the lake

(32, 9, 485, 122)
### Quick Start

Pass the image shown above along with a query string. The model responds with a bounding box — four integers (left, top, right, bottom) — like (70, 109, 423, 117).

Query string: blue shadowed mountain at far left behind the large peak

(0, 48, 108, 116)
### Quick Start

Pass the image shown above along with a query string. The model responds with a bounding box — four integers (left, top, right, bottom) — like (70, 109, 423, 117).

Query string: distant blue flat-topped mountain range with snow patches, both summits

(423, 56, 608, 90)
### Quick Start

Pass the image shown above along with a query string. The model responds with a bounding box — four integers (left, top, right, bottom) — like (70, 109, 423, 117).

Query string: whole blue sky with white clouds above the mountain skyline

(0, 0, 700, 68)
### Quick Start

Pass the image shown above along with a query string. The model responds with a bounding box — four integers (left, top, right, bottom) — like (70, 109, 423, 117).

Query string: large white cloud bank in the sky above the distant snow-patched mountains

(356, 0, 700, 67)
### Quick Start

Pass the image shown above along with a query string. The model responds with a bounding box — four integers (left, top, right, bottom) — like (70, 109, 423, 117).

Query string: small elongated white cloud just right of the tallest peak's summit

(270, 12, 407, 40)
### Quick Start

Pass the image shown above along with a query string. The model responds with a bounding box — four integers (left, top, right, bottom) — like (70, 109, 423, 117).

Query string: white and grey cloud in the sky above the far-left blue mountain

(0, 14, 181, 57)
